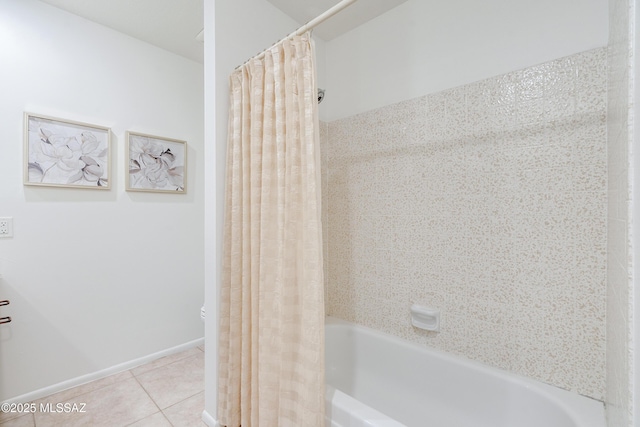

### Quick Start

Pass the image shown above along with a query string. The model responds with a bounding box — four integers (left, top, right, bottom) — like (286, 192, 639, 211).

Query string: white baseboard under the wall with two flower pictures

(2, 338, 204, 403)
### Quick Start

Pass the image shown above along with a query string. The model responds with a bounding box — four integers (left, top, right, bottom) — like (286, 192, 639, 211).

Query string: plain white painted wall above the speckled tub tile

(323, 0, 608, 120)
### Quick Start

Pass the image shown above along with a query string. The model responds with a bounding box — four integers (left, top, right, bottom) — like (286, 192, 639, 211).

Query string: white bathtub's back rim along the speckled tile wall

(325, 316, 606, 427)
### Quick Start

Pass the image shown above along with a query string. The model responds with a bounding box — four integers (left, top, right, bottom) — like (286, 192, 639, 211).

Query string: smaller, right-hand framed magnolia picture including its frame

(125, 131, 187, 194)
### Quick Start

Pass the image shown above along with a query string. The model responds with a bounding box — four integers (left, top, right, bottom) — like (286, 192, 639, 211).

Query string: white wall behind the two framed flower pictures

(0, 0, 204, 401)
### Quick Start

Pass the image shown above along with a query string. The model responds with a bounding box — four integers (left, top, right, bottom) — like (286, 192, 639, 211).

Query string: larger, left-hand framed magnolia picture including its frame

(24, 112, 111, 190)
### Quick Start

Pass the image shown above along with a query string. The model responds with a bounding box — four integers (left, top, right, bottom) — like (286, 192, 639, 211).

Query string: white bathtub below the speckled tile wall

(326, 317, 605, 427)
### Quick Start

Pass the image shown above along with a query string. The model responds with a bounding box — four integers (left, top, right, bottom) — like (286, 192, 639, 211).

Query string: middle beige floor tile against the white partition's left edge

(136, 351, 204, 409)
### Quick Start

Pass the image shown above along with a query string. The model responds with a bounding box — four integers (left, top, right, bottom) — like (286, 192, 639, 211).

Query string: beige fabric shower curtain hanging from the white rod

(218, 33, 324, 427)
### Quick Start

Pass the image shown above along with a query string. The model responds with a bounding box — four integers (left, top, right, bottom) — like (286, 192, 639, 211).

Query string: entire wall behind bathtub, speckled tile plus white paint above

(321, 0, 608, 399)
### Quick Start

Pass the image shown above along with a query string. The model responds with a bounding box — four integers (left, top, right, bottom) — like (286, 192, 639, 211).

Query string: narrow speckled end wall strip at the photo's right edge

(607, 0, 640, 427)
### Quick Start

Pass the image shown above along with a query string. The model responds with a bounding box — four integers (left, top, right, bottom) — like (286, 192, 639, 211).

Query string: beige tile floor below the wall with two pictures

(0, 347, 206, 427)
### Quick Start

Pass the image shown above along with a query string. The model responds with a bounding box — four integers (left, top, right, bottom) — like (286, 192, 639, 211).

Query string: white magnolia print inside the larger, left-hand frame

(28, 119, 109, 187)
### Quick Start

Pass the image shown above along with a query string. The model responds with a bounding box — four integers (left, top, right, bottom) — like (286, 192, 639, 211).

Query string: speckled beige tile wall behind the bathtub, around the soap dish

(321, 48, 607, 399)
